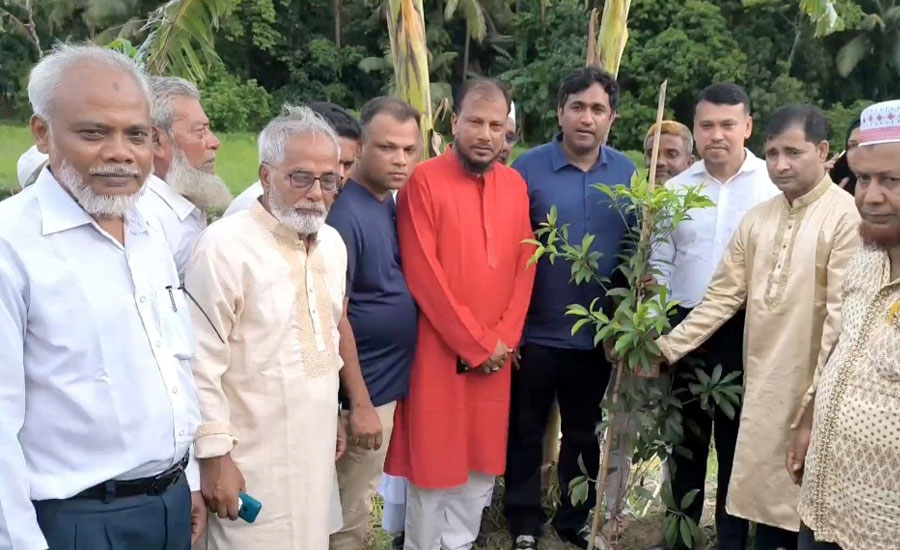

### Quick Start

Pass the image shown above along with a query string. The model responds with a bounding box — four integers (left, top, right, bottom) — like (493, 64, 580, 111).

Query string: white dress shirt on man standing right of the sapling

(653, 149, 780, 308)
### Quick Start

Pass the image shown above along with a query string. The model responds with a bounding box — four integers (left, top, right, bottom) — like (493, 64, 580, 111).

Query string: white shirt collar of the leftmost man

(34, 166, 147, 235)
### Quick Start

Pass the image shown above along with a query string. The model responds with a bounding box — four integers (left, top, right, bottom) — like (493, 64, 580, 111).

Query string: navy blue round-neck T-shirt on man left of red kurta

(328, 180, 418, 407)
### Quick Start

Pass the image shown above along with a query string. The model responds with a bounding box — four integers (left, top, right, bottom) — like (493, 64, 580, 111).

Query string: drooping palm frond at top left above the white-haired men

(139, 0, 235, 81)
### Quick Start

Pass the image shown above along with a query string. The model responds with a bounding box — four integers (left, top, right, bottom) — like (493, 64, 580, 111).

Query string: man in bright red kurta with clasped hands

(385, 80, 534, 550)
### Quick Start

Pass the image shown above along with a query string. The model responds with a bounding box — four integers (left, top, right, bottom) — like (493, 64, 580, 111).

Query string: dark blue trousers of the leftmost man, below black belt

(33, 477, 191, 550)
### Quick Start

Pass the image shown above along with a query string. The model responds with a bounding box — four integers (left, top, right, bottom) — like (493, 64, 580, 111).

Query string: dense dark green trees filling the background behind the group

(0, 0, 884, 149)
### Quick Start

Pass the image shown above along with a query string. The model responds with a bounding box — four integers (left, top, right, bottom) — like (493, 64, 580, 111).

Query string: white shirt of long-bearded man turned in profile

(137, 174, 206, 280)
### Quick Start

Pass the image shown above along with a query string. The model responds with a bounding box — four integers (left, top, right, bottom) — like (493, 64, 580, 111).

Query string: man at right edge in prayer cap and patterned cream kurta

(787, 100, 900, 550)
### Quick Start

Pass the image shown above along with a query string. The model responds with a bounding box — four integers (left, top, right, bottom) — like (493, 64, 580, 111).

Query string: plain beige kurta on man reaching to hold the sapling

(659, 176, 860, 531)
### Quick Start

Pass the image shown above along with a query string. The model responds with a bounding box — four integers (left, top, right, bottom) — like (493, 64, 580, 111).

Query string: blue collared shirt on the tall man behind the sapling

(513, 134, 635, 349)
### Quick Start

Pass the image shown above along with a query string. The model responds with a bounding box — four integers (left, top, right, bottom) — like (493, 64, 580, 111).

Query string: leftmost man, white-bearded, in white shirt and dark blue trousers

(0, 45, 206, 550)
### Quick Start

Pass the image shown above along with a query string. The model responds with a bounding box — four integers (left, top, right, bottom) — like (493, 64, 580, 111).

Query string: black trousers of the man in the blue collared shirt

(506, 344, 610, 537)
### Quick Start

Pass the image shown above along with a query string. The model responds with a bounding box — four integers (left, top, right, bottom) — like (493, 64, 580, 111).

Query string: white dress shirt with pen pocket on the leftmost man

(0, 168, 200, 550)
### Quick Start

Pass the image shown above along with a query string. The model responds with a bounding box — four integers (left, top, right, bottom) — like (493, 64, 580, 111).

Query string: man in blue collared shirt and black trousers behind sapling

(506, 67, 635, 549)
